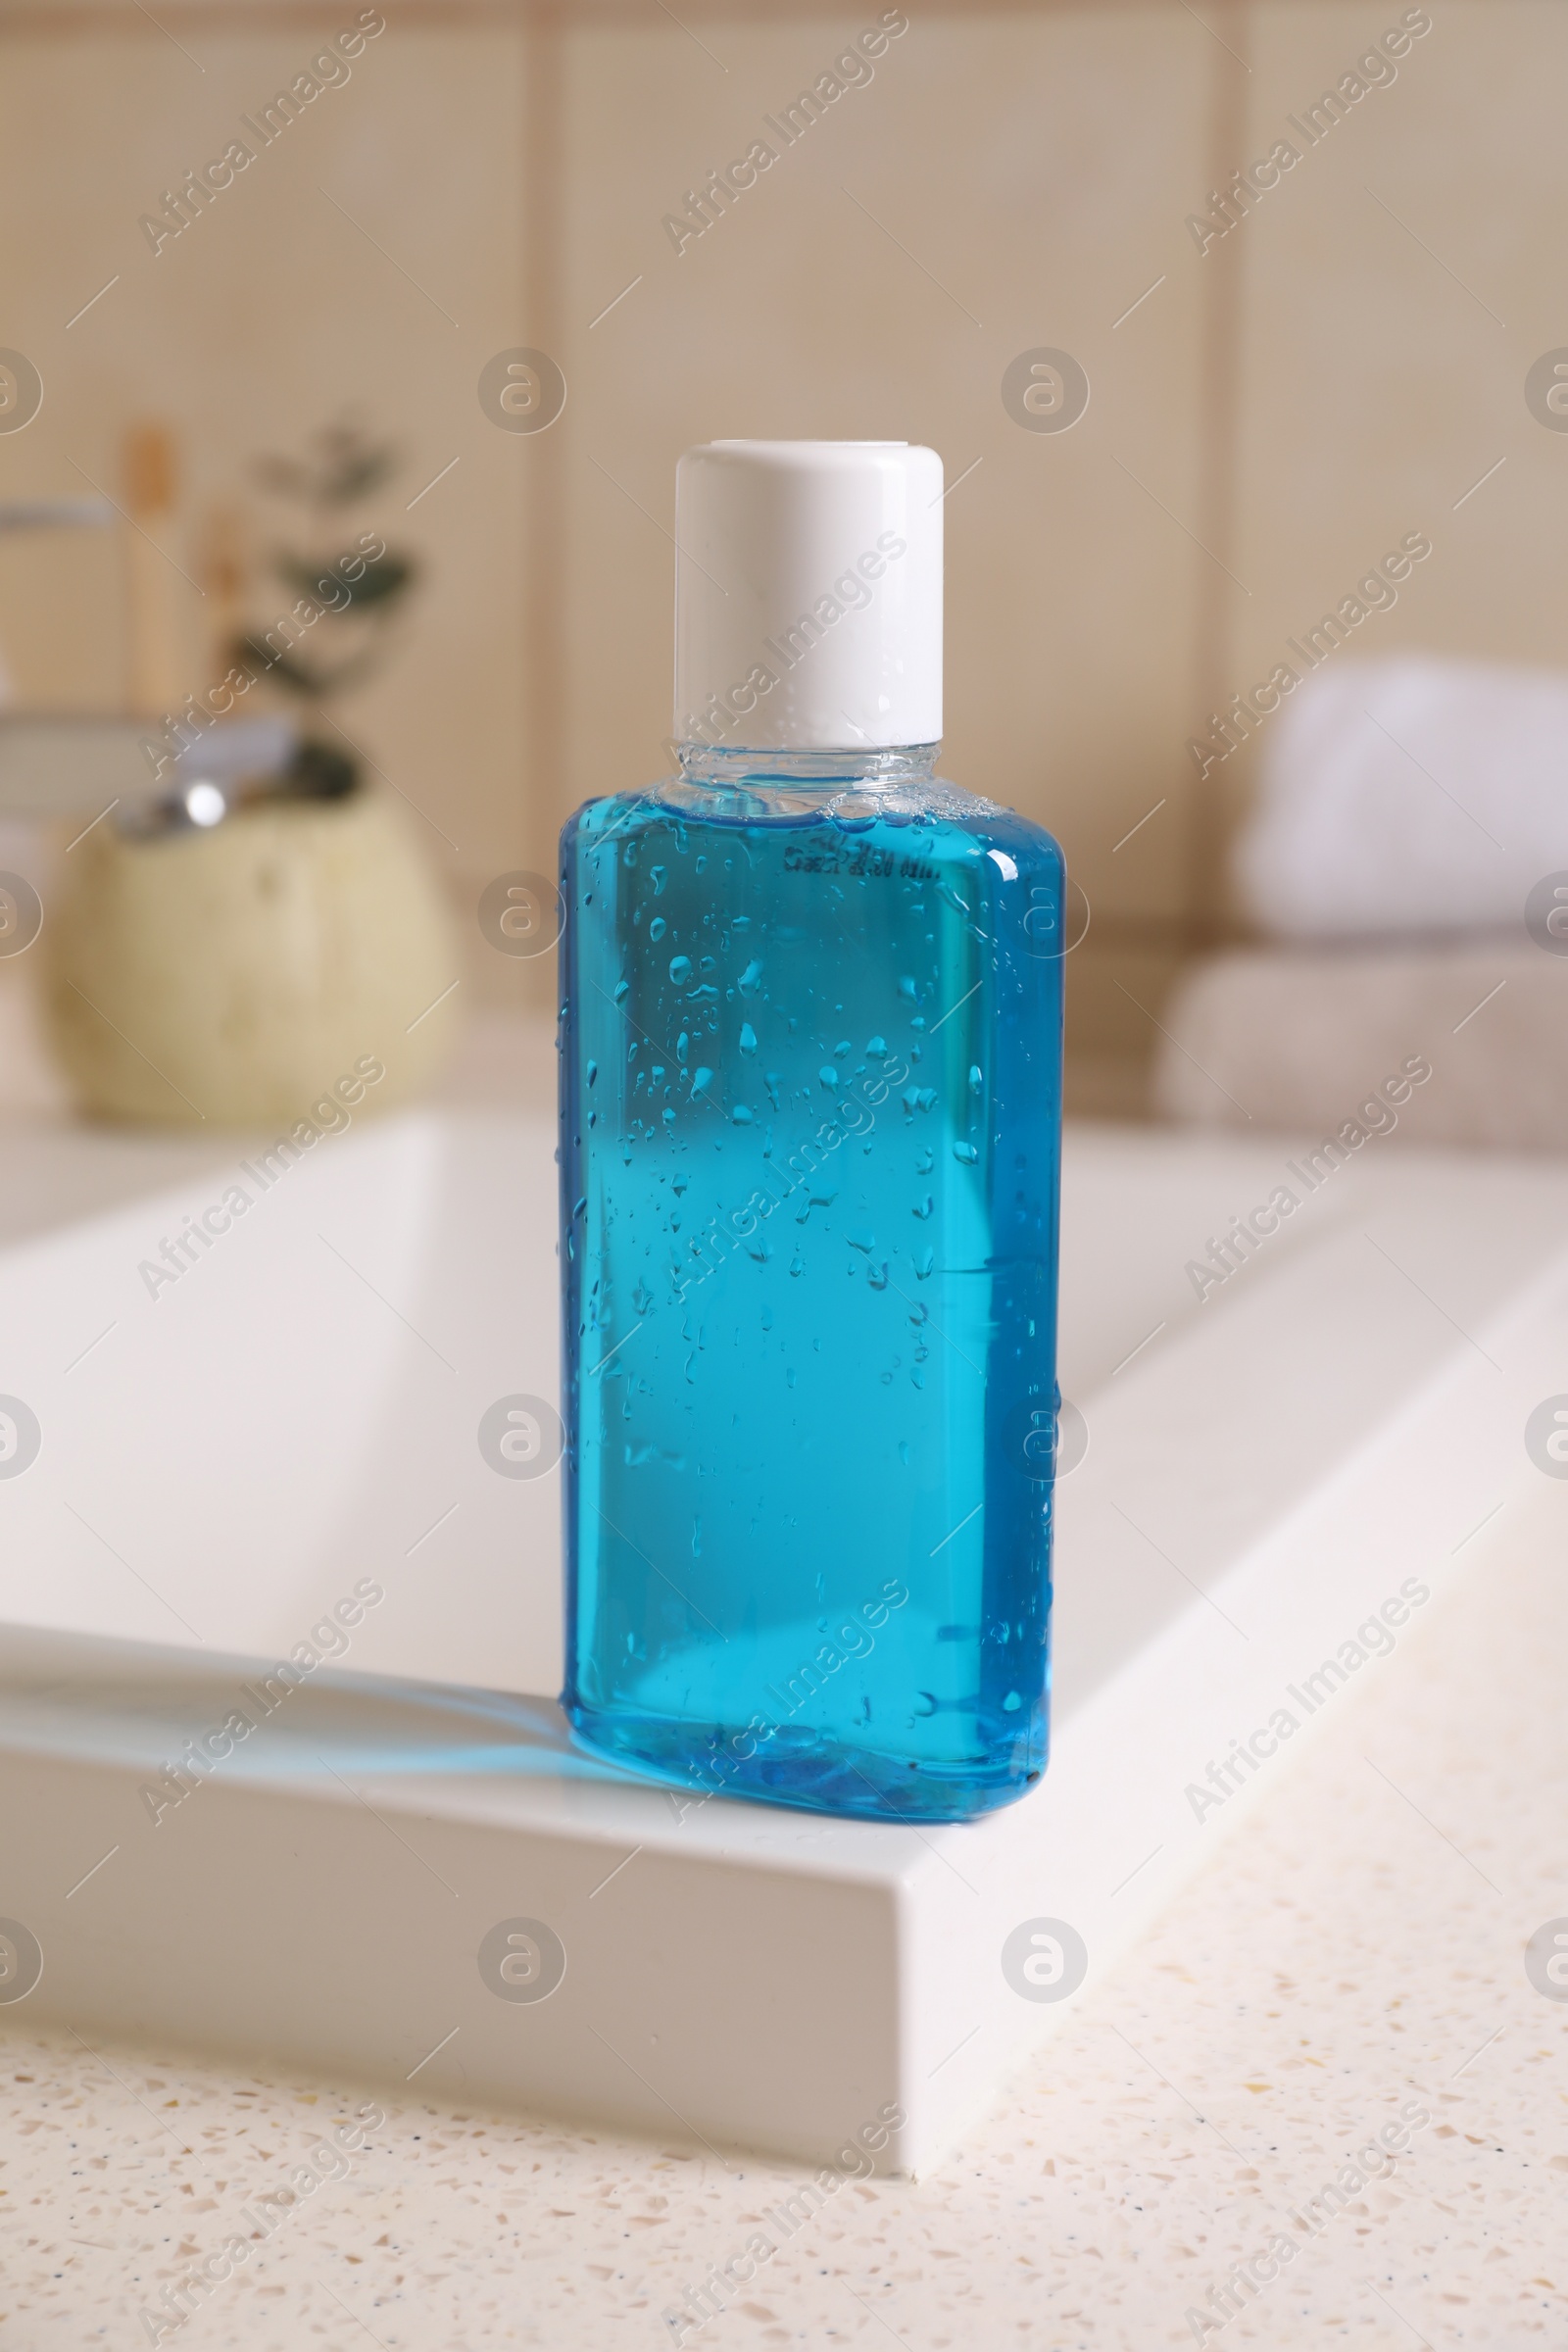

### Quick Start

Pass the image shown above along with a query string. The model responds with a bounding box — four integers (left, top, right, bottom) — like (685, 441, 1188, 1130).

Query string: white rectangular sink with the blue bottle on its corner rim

(0, 1049, 1568, 2169)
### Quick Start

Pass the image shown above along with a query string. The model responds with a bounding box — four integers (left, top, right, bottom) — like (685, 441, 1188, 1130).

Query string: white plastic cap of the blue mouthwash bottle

(674, 440, 943, 751)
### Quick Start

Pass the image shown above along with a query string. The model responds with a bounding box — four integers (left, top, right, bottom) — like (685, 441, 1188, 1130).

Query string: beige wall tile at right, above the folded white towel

(1199, 0, 1568, 884)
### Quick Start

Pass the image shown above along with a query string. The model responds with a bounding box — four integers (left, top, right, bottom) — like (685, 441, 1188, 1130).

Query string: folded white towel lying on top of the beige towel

(1237, 657, 1568, 939)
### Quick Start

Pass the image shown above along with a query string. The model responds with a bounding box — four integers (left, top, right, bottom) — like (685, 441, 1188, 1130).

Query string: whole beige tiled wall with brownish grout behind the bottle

(0, 0, 1568, 1099)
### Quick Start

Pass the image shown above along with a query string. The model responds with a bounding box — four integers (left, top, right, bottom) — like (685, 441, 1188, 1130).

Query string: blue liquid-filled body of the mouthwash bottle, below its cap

(562, 755, 1065, 1821)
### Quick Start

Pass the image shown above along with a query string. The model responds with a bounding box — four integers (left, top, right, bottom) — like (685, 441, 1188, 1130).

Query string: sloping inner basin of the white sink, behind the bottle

(0, 1082, 1325, 1695)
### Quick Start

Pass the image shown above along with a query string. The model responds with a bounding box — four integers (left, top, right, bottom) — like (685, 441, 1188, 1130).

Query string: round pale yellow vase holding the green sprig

(40, 790, 459, 1127)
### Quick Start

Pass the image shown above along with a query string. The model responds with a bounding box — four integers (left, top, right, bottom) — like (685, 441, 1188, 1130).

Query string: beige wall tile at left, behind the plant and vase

(0, 21, 531, 936)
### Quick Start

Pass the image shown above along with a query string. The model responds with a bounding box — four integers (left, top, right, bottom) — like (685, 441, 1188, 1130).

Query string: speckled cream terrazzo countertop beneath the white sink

(0, 1480, 1568, 2352)
